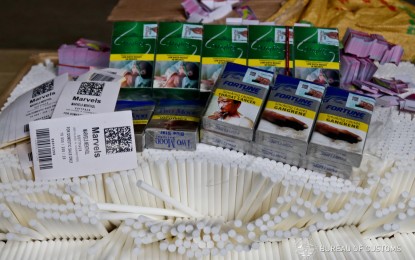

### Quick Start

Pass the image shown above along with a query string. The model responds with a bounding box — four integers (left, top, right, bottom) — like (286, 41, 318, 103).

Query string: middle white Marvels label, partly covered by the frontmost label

(52, 81, 120, 118)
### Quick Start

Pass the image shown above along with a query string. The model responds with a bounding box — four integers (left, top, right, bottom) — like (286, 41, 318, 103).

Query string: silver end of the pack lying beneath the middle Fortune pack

(250, 142, 305, 166)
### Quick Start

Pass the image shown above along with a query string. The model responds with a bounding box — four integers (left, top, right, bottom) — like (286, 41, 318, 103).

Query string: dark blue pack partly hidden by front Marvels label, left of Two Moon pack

(115, 100, 155, 152)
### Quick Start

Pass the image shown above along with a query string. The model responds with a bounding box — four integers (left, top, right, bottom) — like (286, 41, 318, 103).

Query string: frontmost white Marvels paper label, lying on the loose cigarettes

(30, 111, 137, 180)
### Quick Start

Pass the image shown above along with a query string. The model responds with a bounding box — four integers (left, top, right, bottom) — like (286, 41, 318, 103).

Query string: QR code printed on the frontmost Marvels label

(104, 126, 133, 154)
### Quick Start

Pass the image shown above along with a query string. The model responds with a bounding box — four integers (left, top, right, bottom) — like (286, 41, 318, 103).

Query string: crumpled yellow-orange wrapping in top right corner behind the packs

(268, 0, 415, 61)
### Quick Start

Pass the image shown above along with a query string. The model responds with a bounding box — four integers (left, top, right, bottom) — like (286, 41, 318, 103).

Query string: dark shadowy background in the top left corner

(0, 0, 117, 50)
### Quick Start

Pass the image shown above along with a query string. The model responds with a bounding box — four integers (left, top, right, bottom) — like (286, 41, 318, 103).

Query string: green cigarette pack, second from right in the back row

(248, 25, 293, 79)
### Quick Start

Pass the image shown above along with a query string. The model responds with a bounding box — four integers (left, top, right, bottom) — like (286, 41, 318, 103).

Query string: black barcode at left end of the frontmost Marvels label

(36, 128, 53, 170)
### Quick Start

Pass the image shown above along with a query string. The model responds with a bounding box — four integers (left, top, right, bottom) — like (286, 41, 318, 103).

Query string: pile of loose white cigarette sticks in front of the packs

(0, 105, 415, 259)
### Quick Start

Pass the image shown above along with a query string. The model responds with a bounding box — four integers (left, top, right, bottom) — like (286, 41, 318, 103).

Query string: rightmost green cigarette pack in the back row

(294, 26, 340, 87)
